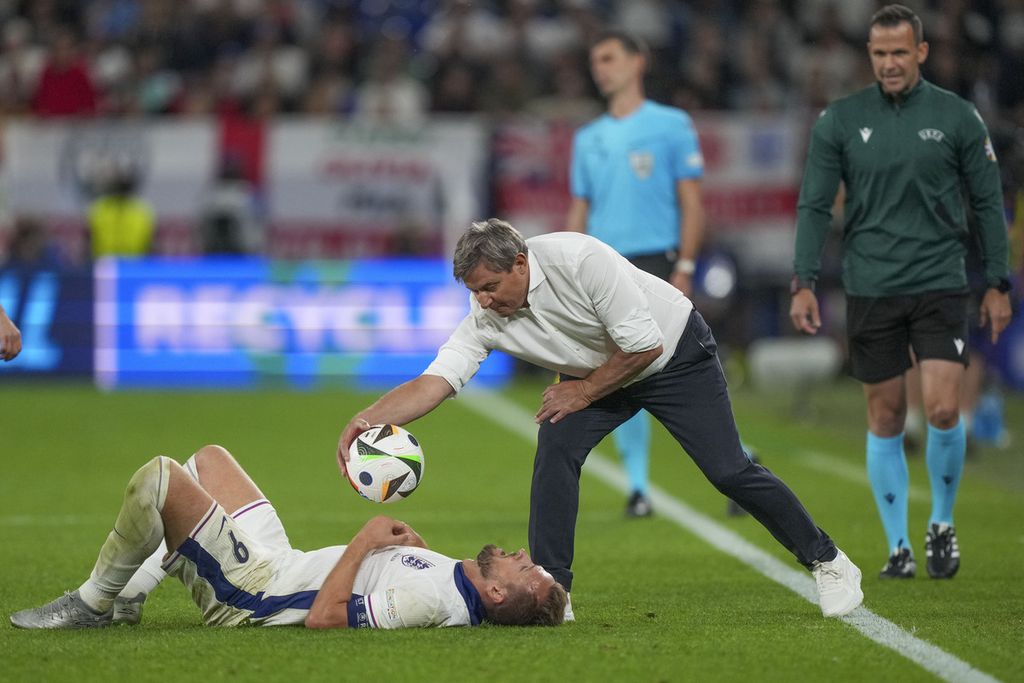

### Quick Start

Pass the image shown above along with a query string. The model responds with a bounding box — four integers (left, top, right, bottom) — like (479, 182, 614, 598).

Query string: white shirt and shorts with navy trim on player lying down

(164, 502, 484, 629)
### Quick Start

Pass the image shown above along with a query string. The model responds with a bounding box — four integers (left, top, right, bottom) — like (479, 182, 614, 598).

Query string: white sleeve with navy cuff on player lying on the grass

(348, 581, 444, 629)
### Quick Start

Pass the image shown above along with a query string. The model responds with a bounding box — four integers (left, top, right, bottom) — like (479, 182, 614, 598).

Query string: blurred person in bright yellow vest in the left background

(88, 169, 156, 258)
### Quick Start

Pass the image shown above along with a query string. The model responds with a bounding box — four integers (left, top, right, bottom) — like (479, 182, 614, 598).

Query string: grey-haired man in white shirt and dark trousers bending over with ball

(338, 218, 863, 616)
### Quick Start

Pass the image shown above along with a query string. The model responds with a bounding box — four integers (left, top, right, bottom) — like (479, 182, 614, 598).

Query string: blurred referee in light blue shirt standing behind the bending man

(565, 31, 705, 517)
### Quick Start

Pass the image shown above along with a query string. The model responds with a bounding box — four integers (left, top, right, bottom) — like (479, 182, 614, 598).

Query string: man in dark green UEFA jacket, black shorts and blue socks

(790, 5, 1011, 579)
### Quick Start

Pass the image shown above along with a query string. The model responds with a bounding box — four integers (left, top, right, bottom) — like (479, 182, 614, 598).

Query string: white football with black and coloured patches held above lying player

(346, 425, 423, 503)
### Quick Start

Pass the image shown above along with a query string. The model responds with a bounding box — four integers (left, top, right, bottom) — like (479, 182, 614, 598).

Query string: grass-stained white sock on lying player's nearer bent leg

(78, 456, 171, 612)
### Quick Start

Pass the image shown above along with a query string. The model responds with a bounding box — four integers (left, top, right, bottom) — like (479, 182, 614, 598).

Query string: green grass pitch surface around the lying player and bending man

(0, 382, 1024, 681)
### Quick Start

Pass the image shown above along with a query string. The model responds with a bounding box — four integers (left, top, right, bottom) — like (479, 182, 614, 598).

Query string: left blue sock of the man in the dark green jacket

(867, 431, 910, 554)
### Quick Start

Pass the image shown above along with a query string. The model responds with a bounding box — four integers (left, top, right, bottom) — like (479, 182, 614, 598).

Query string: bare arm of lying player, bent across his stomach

(306, 515, 426, 629)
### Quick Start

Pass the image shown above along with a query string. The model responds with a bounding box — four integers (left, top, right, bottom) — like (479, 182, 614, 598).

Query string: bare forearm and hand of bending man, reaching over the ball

(338, 375, 455, 470)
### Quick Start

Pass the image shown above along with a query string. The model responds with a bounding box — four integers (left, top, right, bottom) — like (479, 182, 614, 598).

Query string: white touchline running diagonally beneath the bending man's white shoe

(461, 391, 998, 683)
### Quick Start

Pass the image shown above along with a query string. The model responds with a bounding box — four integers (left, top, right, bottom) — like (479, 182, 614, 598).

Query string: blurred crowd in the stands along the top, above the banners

(0, 0, 1024, 126)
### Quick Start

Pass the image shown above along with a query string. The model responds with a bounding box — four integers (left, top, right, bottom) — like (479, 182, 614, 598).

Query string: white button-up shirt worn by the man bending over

(424, 232, 693, 392)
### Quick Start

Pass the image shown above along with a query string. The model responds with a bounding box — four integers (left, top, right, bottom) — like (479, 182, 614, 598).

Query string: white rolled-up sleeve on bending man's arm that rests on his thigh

(578, 244, 665, 353)
